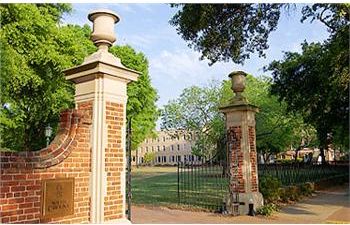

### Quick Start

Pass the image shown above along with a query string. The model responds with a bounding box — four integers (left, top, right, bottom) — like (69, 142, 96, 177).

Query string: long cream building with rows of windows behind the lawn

(132, 131, 201, 165)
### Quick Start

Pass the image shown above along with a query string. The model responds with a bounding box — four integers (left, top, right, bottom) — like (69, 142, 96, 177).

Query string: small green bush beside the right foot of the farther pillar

(259, 176, 281, 203)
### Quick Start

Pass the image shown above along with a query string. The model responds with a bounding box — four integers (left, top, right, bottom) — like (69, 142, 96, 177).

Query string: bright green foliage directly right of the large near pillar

(109, 46, 159, 149)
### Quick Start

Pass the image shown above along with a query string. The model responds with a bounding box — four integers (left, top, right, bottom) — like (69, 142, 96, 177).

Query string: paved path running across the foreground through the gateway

(132, 185, 350, 224)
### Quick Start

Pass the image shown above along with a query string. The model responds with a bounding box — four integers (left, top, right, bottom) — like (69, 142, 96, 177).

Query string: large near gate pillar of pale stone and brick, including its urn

(64, 10, 139, 223)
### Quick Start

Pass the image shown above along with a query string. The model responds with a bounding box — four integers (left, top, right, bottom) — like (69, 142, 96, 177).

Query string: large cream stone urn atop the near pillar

(88, 9, 120, 50)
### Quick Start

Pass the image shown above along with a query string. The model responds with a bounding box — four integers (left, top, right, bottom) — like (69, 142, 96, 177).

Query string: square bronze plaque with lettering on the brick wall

(41, 178, 74, 218)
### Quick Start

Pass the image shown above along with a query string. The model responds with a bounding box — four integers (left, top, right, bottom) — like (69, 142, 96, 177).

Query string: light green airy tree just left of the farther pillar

(161, 83, 225, 161)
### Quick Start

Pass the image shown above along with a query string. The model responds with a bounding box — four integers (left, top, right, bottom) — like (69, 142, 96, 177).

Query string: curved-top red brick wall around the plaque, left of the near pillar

(0, 102, 92, 223)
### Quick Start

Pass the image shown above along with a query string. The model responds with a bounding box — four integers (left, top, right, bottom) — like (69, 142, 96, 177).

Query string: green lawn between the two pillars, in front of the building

(131, 167, 227, 211)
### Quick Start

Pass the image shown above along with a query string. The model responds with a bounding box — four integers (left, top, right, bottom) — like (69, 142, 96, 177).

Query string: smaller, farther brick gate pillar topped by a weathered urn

(220, 71, 263, 215)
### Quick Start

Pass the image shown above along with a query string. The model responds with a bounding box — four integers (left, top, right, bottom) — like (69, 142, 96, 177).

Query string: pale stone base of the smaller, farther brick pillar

(226, 192, 264, 215)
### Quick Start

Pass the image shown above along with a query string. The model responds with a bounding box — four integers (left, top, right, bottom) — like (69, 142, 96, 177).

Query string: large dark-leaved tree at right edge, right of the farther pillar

(267, 4, 350, 161)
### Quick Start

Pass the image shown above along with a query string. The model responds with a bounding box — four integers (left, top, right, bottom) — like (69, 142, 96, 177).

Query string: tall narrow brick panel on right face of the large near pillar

(104, 102, 125, 221)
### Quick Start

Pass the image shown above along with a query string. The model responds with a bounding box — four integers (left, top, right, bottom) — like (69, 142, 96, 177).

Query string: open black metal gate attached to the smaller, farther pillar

(177, 129, 240, 215)
